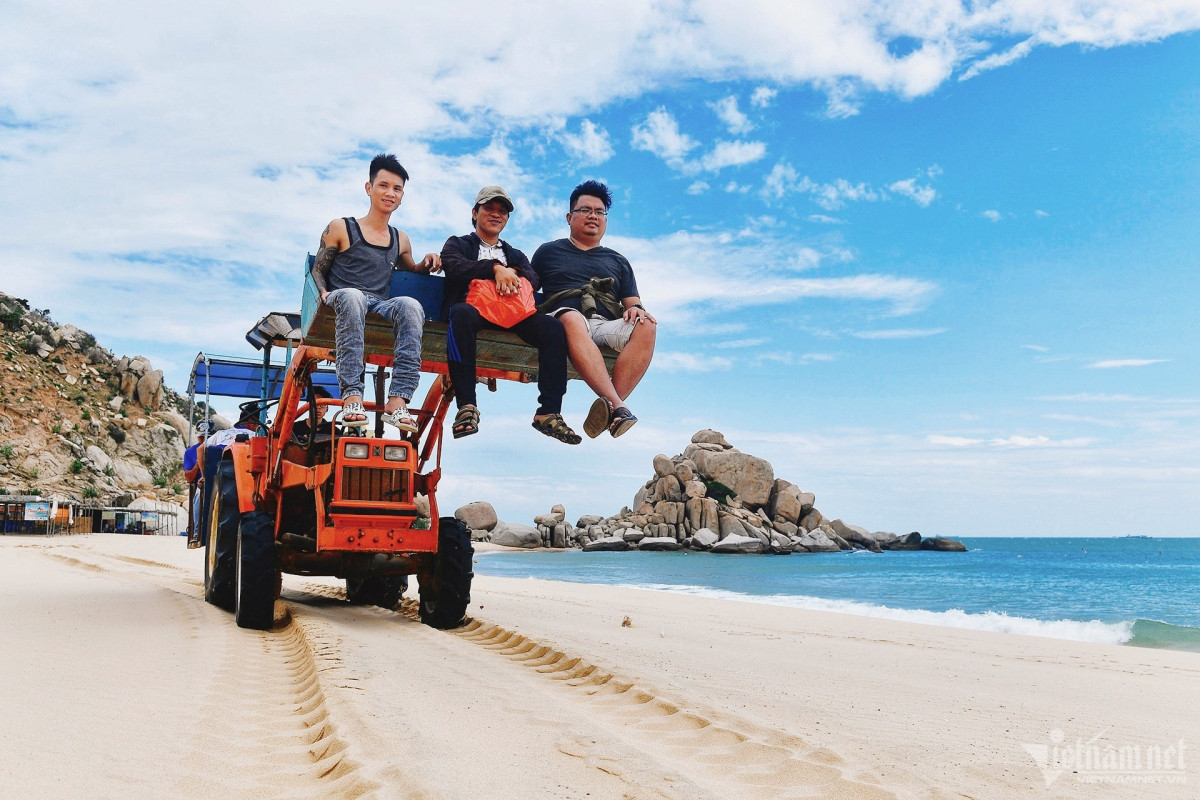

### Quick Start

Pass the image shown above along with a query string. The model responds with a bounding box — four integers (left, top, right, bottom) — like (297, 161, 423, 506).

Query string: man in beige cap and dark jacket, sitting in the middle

(442, 186, 582, 445)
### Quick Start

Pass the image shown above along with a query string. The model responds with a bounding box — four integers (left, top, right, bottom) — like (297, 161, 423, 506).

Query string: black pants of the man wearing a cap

(446, 302, 566, 414)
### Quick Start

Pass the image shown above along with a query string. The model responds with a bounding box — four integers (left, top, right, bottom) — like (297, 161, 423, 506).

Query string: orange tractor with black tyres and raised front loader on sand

(188, 261, 614, 628)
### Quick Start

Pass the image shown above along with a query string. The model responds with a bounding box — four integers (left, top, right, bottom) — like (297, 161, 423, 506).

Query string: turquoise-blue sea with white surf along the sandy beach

(475, 536, 1200, 652)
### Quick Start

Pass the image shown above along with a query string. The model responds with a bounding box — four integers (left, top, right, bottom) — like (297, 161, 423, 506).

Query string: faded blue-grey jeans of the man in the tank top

(325, 289, 425, 403)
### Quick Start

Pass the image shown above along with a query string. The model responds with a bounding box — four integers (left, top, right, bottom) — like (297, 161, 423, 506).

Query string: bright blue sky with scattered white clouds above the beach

(0, 0, 1200, 536)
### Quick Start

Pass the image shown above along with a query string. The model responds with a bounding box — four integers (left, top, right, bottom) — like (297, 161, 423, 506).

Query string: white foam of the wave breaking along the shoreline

(626, 583, 1133, 644)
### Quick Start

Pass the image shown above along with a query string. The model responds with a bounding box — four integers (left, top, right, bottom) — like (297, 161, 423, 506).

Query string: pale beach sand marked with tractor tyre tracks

(0, 534, 1200, 800)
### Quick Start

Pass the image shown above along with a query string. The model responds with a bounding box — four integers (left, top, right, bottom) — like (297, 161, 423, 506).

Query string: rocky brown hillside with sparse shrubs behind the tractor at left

(0, 293, 199, 520)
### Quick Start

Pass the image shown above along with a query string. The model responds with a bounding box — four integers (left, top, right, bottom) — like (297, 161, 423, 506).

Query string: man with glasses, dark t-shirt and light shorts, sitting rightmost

(532, 181, 658, 439)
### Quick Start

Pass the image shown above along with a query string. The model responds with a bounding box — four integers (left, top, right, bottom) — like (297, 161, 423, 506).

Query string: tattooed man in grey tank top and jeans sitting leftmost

(312, 154, 442, 433)
